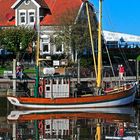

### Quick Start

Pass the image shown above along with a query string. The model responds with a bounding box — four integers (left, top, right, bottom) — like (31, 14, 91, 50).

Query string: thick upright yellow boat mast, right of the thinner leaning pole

(97, 0, 102, 88)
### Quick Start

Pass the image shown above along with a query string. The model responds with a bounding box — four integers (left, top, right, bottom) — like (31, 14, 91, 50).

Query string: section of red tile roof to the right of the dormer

(41, 0, 83, 25)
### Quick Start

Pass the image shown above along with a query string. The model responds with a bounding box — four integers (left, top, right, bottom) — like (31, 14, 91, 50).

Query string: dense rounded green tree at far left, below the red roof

(0, 27, 36, 61)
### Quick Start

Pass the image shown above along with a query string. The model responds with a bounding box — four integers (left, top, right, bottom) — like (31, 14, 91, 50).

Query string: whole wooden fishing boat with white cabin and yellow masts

(7, 0, 137, 109)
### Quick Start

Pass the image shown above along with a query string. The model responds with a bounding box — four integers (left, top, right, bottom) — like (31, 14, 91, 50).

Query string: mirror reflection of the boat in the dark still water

(7, 107, 138, 140)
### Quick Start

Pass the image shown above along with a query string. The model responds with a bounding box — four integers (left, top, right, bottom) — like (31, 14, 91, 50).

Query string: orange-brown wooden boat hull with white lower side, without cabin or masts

(7, 83, 137, 109)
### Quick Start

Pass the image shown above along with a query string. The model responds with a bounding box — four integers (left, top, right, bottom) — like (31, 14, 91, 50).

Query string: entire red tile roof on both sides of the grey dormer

(0, 0, 83, 26)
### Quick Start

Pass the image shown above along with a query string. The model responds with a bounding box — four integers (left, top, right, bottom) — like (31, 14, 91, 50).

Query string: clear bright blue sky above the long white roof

(90, 0, 140, 36)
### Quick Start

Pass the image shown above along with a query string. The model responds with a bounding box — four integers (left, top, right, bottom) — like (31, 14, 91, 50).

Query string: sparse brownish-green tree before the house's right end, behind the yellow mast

(51, 2, 98, 65)
